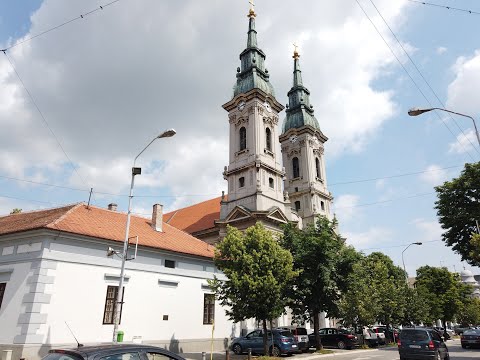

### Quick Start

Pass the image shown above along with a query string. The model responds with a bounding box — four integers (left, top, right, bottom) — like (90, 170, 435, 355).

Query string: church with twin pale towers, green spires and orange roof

(163, 8, 333, 244)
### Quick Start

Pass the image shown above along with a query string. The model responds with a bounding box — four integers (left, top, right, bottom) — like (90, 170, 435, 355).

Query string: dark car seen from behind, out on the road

(398, 328, 450, 360)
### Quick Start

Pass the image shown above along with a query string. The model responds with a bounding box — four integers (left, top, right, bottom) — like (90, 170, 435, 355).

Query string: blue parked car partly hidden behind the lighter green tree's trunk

(232, 329, 299, 356)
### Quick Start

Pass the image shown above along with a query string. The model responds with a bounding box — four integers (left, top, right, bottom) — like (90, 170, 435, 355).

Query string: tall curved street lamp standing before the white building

(113, 129, 177, 342)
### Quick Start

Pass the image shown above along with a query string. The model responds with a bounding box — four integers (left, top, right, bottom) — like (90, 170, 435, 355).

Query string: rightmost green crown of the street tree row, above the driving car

(415, 266, 472, 323)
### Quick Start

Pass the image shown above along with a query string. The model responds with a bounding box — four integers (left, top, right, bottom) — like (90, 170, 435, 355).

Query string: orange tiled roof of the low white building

(0, 203, 213, 258)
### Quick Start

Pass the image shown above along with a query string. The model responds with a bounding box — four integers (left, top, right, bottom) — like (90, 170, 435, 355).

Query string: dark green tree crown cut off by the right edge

(435, 163, 480, 266)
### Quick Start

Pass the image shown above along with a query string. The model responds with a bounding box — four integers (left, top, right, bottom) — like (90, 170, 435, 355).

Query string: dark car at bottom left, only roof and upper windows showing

(43, 344, 185, 360)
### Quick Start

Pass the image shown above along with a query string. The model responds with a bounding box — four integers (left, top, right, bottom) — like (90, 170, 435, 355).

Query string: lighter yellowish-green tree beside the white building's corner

(210, 223, 297, 354)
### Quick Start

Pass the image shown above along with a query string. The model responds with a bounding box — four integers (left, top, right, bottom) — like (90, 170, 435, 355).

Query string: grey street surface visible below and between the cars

(181, 340, 480, 360)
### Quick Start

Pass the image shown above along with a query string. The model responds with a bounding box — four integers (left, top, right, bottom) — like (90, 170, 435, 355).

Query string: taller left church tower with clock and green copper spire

(217, 7, 290, 238)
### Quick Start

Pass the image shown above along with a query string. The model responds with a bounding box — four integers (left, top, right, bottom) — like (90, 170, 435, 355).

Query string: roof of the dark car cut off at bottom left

(49, 344, 184, 360)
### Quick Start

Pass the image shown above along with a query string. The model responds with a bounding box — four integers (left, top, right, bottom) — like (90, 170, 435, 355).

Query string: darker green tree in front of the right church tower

(281, 217, 357, 350)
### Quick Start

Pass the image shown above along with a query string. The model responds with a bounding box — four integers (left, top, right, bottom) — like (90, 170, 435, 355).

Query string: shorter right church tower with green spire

(280, 49, 333, 225)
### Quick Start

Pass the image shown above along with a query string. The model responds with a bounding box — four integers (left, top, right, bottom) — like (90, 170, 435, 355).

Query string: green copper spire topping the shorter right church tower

(282, 51, 320, 134)
